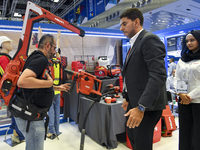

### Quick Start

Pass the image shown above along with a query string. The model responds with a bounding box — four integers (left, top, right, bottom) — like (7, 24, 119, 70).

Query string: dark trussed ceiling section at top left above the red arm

(0, 0, 83, 20)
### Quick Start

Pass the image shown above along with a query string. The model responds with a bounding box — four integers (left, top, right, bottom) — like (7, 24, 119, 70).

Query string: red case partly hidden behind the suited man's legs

(126, 119, 161, 150)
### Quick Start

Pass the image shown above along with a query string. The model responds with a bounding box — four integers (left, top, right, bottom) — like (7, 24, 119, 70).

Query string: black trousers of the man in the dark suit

(127, 104, 162, 150)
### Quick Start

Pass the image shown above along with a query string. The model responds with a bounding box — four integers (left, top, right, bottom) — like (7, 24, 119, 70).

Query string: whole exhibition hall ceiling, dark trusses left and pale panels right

(0, 0, 200, 32)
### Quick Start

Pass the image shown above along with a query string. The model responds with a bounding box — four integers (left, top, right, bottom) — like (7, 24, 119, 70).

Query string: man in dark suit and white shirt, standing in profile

(120, 8, 167, 150)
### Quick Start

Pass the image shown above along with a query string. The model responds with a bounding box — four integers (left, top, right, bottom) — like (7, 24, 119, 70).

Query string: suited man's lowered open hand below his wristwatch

(124, 107, 144, 128)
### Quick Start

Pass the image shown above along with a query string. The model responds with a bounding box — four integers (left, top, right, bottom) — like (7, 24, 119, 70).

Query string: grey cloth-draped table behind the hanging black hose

(78, 97, 126, 149)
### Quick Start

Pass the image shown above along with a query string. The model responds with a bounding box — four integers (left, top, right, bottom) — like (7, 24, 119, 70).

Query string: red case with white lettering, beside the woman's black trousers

(162, 105, 177, 137)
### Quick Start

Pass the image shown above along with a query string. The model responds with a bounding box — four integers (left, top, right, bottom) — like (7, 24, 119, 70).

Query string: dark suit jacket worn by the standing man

(123, 30, 167, 111)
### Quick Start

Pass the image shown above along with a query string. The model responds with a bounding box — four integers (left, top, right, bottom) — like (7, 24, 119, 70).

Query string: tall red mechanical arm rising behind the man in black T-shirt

(0, 1, 85, 105)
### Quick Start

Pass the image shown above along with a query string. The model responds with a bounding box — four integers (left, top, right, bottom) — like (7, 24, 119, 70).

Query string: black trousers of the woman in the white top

(178, 103, 200, 150)
